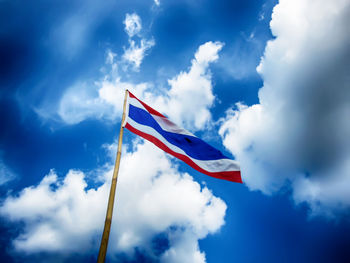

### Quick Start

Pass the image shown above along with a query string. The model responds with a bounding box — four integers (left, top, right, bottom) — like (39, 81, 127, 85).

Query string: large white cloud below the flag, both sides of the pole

(0, 143, 226, 263)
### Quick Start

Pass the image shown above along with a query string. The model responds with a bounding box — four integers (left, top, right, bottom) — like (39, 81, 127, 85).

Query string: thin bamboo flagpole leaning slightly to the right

(97, 90, 128, 263)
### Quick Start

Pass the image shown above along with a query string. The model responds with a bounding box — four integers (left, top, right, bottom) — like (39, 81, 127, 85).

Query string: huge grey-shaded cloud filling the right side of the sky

(220, 0, 350, 216)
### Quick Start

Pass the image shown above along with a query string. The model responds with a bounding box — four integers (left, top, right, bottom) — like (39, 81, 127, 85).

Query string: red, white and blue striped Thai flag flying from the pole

(123, 92, 242, 183)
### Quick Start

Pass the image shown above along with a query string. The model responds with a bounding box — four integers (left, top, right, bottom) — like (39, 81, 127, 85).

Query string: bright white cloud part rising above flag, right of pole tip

(144, 41, 223, 129)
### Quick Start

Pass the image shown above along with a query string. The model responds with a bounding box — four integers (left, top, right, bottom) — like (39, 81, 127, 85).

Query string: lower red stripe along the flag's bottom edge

(125, 123, 243, 183)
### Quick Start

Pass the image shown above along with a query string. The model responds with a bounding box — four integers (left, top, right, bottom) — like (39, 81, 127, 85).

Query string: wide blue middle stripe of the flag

(129, 104, 229, 161)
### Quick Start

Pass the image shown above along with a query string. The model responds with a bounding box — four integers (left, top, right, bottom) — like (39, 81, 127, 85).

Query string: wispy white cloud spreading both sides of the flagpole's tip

(58, 41, 223, 130)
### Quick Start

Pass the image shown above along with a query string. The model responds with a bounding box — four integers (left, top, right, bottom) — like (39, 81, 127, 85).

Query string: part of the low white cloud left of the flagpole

(0, 171, 108, 253)
